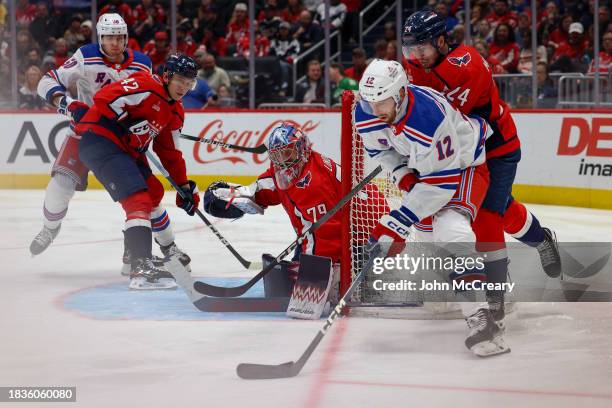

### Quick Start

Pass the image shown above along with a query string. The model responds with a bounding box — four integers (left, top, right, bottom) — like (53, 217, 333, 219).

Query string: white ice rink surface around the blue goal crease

(0, 190, 612, 408)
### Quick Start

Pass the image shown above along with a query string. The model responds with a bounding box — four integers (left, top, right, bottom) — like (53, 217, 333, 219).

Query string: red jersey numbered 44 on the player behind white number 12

(406, 45, 520, 157)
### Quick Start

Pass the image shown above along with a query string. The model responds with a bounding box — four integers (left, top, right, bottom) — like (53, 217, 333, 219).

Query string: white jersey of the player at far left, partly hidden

(38, 44, 151, 106)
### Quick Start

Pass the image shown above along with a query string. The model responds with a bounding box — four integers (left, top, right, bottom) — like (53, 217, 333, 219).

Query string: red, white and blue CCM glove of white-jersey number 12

(367, 210, 412, 258)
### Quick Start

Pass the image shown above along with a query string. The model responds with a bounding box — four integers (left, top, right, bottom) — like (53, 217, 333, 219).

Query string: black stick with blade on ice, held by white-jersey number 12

(236, 255, 376, 380)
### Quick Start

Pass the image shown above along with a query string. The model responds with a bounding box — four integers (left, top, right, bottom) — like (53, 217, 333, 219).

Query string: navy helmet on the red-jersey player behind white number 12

(402, 10, 447, 58)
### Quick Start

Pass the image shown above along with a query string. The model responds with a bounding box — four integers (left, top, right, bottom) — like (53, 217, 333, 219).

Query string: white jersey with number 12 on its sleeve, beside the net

(354, 85, 493, 223)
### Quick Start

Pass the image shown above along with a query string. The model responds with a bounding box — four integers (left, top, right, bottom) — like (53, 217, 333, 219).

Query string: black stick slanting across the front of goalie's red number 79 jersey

(193, 166, 382, 297)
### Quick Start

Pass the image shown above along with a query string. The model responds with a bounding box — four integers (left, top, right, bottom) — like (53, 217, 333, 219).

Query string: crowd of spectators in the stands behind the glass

(0, 0, 612, 108)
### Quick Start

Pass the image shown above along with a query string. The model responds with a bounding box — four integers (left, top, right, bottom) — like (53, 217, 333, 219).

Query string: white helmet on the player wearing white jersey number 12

(359, 58, 410, 118)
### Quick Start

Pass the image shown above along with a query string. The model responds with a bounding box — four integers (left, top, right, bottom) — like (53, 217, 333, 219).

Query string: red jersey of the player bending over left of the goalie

(75, 72, 187, 185)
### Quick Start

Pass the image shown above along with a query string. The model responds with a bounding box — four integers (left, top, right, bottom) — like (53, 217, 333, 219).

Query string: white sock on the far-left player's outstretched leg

(43, 173, 76, 229)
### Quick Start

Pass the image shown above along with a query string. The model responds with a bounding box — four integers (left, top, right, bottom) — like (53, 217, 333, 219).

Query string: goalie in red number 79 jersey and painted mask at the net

(204, 123, 388, 316)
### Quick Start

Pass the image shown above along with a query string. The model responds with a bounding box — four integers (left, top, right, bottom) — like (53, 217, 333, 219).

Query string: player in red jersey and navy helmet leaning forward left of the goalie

(76, 55, 199, 289)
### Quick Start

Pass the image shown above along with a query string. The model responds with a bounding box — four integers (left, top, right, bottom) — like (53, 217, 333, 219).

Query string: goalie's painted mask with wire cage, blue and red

(267, 123, 312, 190)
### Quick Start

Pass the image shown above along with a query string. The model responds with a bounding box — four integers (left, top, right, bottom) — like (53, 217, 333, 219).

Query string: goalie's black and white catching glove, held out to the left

(204, 181, 264, 219)
